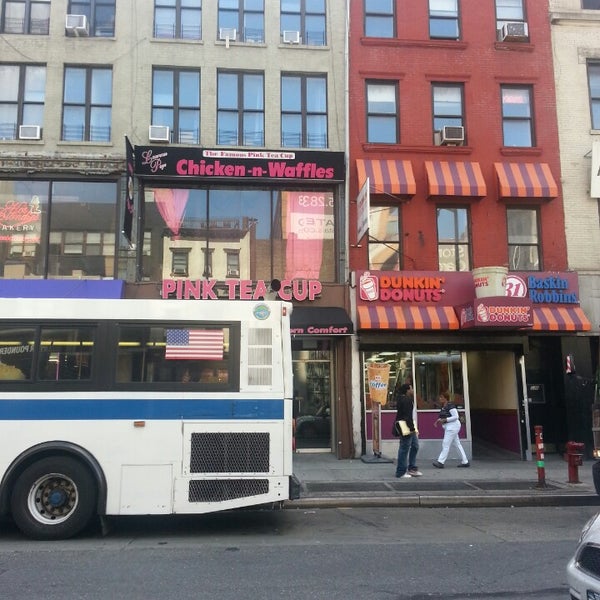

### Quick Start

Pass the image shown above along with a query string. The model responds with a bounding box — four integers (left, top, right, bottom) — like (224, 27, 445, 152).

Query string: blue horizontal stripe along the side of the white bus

(0, 399, 283, 421)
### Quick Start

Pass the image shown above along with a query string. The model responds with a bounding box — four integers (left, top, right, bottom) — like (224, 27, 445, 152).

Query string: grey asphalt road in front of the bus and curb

(0, 507, 596, 600)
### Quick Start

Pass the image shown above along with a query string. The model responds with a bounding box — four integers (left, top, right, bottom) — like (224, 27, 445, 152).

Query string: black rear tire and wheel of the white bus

(11, 456, 96, 540)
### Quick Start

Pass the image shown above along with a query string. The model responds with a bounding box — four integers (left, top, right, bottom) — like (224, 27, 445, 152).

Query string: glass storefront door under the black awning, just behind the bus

(293, 350, 333, 451)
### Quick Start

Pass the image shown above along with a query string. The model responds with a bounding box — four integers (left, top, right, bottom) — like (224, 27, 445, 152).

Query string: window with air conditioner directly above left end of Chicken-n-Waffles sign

(152, 69, 200, 144)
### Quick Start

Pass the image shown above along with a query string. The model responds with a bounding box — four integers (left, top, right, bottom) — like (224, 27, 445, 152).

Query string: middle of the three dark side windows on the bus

(38, 327, 94, 381)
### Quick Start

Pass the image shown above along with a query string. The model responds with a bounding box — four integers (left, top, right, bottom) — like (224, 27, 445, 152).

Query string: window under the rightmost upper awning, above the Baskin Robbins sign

(506, 208, 541, 271)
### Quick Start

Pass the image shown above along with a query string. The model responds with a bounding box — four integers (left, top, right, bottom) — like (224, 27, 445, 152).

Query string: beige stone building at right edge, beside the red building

(550, 0, 600, 335)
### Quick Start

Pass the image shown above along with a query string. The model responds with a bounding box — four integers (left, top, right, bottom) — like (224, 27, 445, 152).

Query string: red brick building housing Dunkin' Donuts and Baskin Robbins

(349, 0, 592, 458)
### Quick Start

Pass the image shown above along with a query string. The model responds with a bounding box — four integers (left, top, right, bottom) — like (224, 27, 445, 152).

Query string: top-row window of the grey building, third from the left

(154, 0, 202, 40)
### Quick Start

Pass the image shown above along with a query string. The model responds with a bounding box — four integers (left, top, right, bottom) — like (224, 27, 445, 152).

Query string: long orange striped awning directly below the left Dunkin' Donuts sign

(358, 306, 459, 330)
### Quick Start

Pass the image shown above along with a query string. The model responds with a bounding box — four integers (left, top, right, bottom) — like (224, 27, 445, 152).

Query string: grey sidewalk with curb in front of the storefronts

(286, 453, 600, 509)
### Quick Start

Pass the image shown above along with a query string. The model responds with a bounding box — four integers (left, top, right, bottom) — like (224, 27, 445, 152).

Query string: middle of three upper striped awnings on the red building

(425, 160, 487, 198)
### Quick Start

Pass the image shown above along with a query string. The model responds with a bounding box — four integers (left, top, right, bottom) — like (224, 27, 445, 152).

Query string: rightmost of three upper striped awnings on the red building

(494, 163, 558, 198)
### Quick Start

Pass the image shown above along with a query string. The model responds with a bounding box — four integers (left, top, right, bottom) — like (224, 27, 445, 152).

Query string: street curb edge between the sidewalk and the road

(283, 490, 600, 510)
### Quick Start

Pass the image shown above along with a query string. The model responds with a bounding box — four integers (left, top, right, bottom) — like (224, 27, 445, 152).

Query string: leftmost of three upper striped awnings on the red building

(356, 159, 417, 196)
